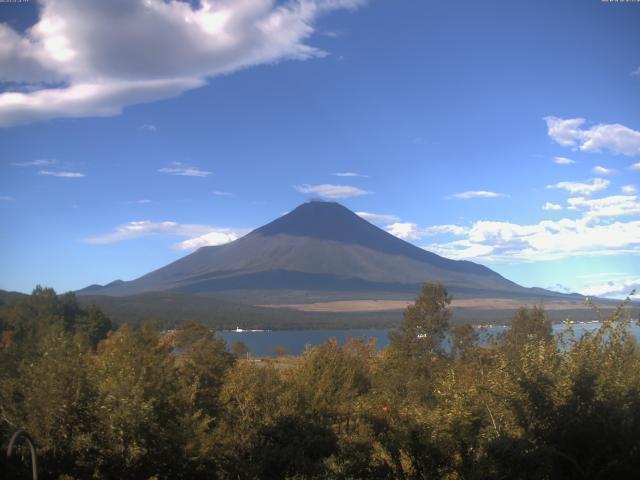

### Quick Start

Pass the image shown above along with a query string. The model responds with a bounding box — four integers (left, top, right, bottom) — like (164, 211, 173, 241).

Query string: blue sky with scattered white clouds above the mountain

(0, 0, 640, 296)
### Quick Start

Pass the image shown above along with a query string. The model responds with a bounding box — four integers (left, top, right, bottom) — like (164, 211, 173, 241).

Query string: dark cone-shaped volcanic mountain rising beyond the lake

(78, 202, 568, 296)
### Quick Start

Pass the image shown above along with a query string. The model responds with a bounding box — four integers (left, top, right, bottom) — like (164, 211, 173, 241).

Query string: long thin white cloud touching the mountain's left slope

(84, 220, 246, 250)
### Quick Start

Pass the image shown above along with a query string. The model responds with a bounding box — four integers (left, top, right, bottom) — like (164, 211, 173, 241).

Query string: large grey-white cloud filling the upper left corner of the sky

(0, 0, 364, 127)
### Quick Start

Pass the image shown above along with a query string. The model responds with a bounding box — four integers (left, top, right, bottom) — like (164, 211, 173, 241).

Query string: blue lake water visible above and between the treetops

(219, 323, 640, 357)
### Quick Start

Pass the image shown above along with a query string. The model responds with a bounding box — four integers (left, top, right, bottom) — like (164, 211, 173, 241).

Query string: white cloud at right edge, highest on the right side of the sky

(544, 116, 640, 156)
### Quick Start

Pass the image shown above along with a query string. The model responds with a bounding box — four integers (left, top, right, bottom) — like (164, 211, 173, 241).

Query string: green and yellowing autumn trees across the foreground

(0, 284, 640, 480)
